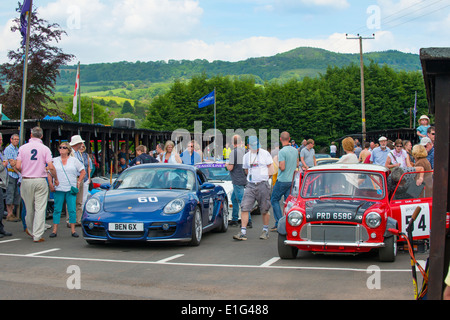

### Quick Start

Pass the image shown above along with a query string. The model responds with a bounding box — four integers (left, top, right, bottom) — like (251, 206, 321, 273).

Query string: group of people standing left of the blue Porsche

(0, 127, 92, 242)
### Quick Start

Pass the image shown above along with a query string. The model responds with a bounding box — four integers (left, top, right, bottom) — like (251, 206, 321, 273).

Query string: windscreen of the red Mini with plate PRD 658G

(301, 171, 385, 199)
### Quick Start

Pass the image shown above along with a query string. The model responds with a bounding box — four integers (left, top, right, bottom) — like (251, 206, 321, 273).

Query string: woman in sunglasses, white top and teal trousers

(48, 142, 86, 238)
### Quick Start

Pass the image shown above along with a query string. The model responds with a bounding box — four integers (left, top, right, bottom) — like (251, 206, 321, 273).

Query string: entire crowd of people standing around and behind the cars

(0, 116, 435, 242)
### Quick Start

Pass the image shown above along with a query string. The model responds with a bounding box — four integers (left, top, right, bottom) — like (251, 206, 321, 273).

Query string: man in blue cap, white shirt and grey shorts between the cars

(233, 136, 273, 240)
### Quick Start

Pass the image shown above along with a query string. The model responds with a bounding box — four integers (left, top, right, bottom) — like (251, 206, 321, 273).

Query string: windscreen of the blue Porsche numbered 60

(113, 167, 195, 190)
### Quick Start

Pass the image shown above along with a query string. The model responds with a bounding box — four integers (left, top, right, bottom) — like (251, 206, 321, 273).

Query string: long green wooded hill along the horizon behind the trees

(57, 47, 421, 93)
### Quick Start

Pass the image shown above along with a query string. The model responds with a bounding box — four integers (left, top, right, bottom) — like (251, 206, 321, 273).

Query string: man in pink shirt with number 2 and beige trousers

(16, 127, 59, 242)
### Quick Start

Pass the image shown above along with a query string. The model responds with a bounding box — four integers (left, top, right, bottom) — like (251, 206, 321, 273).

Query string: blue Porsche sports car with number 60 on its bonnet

(82, 163, 228, 245)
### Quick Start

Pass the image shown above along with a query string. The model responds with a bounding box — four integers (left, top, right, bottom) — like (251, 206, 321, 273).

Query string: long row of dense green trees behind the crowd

(144, 62, 427, 151)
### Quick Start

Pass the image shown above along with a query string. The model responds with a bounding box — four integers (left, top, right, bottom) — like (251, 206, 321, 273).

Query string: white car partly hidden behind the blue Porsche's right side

(195, 162, 237, 220)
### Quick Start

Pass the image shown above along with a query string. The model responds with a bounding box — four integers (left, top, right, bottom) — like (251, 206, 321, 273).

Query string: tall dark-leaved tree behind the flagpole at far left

(0, 5, 74, 119)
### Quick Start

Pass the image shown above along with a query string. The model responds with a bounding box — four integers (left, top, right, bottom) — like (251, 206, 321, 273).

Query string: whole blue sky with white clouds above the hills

(0, 0, 450, 64)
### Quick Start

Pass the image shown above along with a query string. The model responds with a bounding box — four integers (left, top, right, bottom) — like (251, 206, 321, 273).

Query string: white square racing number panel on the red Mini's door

(400, 203, 430, 237)
